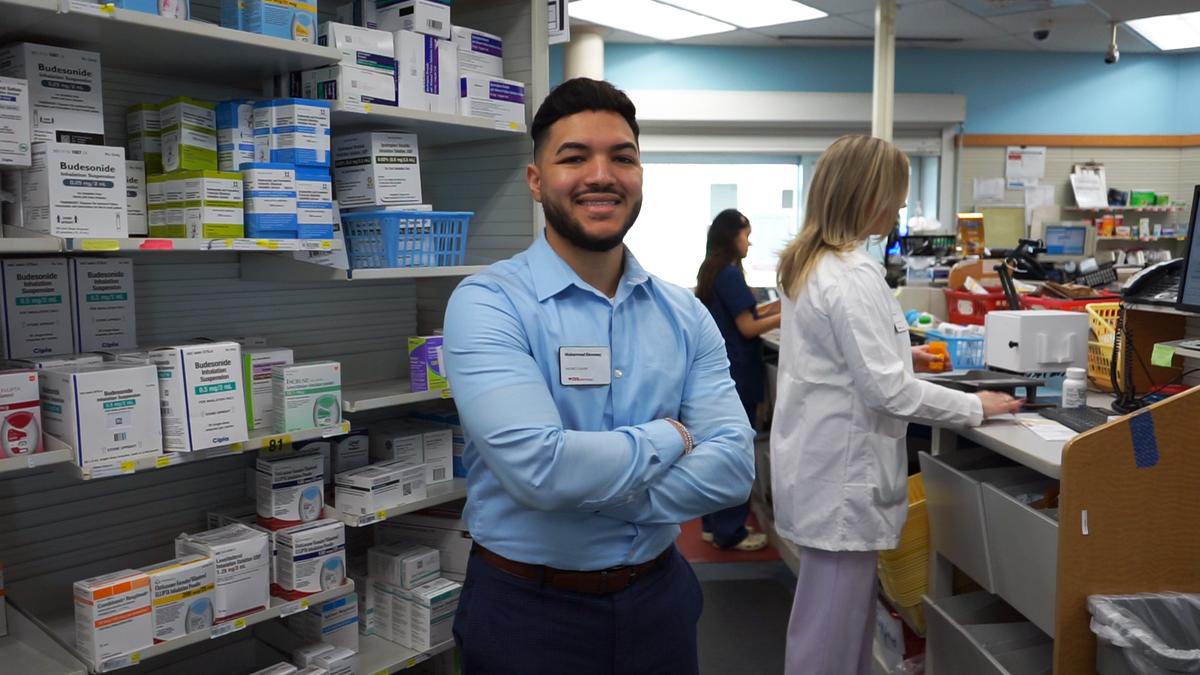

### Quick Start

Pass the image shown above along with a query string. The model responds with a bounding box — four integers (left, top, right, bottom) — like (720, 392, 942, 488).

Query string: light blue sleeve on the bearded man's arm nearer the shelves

(444, 280, 691, 512)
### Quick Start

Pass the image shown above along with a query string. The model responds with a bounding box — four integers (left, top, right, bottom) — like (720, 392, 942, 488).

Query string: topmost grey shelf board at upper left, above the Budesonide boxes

(0, 0, 341, 89)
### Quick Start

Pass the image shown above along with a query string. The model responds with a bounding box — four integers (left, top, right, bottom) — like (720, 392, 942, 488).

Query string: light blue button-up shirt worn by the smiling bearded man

(444, 237, 754, 571)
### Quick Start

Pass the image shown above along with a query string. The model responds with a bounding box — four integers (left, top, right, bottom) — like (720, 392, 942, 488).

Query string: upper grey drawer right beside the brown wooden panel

(983, 478, 1058, 638)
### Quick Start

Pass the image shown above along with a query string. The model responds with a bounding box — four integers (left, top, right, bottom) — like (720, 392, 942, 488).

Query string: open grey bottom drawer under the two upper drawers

(924, 591, 1054, 675)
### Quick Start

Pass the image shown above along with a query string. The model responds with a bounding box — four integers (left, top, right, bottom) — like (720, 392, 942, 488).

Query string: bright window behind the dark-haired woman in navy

(625, 157, 803, 288)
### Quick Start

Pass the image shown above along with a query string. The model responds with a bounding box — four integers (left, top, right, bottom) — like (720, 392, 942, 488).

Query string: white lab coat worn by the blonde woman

(770, 251, 983, 551)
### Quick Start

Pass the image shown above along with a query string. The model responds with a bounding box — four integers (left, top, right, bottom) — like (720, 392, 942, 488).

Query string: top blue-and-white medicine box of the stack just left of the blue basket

(254, 98, 331, 168)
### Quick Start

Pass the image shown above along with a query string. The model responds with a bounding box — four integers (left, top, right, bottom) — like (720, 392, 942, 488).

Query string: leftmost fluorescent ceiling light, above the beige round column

(570, 0, 737, 40)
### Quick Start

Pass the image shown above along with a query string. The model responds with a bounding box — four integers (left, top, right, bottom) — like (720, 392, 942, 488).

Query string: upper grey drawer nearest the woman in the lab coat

(919, 448, 1040, 591)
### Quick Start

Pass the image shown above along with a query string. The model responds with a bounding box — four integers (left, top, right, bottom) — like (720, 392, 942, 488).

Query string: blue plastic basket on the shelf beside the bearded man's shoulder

(342, 211, 475, 269)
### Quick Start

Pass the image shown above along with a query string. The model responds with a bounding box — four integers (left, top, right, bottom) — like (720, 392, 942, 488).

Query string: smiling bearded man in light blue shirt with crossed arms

(444, 78, 754, 675)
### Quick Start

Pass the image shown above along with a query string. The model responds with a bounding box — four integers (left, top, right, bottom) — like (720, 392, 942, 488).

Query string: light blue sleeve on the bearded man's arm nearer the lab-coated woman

(602, 303, 755, 525)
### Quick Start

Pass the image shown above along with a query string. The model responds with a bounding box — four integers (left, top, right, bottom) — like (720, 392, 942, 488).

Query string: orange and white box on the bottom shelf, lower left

(74, 569, 154, 663)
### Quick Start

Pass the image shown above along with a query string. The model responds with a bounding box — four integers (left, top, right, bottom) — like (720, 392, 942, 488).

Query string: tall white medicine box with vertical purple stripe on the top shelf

(395, 30, 458, 115)
